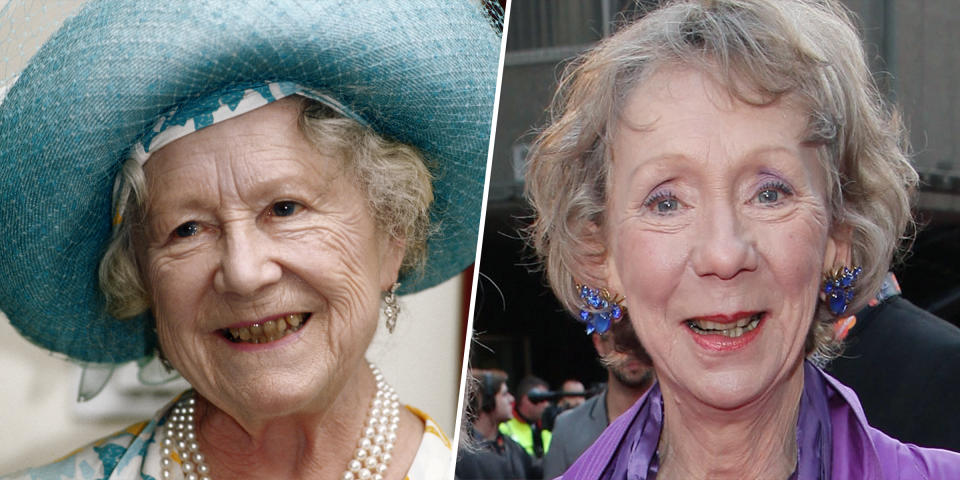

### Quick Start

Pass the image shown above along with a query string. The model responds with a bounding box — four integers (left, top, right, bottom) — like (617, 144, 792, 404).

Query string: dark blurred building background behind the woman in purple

(471, 0, 960, 400)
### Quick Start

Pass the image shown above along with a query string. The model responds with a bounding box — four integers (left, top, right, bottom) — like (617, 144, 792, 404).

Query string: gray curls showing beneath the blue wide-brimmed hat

(99, 98, 433, 318)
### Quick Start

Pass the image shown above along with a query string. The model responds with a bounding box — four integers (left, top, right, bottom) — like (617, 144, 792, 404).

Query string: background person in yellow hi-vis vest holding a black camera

(500, 375, 551, 476)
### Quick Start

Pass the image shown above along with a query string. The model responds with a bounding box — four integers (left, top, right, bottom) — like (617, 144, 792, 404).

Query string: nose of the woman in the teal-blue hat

(214, 223, 283, 296)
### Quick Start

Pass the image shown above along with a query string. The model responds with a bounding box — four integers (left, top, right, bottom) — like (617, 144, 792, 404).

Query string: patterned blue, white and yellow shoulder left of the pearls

(2, 421, 153, 480)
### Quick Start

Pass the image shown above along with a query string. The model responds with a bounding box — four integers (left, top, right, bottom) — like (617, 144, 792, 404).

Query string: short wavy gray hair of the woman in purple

(526, 0, 918, 358)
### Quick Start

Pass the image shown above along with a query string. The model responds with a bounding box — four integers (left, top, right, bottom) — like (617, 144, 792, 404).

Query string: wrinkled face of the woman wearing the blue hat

(137, 99, 402, 416)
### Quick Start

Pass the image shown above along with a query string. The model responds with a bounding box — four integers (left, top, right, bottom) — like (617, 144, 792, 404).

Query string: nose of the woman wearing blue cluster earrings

(693, 202, 757, 280)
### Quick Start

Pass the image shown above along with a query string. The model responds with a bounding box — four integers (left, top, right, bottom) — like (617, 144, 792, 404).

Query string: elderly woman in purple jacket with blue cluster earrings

(527, 0, 960, 480)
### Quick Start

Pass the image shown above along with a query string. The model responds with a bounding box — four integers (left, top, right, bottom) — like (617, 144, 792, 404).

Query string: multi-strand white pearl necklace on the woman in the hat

(160, 363, 400, 480)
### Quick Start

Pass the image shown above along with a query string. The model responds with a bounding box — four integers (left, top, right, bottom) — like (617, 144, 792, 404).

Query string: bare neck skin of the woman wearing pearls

(197, 359, 423, 479)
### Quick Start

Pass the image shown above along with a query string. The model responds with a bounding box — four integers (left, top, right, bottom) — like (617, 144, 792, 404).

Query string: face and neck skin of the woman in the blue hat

(136, 98, 423, 479)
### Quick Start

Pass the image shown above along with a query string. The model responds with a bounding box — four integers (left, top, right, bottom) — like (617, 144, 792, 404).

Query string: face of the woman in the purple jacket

(604, 68, 838, 408)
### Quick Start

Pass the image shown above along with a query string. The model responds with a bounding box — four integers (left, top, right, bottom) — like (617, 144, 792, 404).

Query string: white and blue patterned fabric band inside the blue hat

(130, 82, 367, 165)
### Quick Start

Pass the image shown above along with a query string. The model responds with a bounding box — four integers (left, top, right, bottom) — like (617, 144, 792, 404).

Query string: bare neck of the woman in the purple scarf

(657, 362, 803, 480)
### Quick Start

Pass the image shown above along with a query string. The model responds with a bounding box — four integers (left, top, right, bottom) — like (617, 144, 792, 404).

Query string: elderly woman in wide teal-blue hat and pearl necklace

(0, 0, 500, 480)
